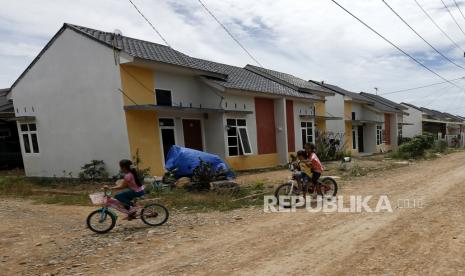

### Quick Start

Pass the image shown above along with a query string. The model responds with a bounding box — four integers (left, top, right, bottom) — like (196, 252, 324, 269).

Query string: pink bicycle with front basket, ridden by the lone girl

(86, 188, 169, 234)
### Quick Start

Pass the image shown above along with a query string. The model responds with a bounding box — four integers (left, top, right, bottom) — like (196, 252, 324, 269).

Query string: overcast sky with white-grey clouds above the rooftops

(0, 0, 465, 115)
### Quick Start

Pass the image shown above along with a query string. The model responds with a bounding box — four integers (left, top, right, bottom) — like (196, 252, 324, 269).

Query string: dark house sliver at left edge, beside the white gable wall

(0, 88, 23, 168)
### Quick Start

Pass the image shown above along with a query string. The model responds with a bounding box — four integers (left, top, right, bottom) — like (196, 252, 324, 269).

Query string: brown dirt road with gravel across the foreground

(0, 152, 465, 275)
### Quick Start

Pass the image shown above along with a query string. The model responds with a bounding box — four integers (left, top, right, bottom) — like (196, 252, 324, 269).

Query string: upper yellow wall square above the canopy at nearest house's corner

(120, 65, 156, 105)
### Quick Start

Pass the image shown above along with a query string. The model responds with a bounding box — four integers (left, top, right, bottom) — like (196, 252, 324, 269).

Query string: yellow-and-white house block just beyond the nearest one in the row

(310, 80, 404, 154)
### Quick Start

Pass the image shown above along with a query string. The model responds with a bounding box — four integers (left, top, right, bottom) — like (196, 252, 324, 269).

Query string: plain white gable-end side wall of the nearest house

(12, 29, 131, 177)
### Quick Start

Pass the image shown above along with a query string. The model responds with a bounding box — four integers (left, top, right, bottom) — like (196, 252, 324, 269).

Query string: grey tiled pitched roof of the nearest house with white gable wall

(12, 23, 322, 100)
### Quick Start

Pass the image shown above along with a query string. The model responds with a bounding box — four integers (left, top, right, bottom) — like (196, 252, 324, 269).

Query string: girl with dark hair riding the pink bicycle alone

(104, 159, 145, 220)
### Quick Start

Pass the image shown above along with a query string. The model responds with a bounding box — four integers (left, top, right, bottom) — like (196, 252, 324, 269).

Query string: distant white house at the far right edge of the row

(402, 103, 465, 142)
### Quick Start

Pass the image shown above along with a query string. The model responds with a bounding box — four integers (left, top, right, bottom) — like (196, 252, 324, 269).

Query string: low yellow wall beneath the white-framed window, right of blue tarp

(226, 153, 279, 171)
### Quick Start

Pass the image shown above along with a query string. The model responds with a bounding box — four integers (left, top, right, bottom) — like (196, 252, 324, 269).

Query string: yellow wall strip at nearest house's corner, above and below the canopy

(120, 65, 164, 175)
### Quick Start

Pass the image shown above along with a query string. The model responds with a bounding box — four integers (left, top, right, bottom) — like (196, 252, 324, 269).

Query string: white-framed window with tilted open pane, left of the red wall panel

(226, 119, 252, 156)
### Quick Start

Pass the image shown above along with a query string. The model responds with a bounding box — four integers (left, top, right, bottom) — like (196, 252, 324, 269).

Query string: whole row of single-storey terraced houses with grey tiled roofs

(3, 24, 463, 176)
